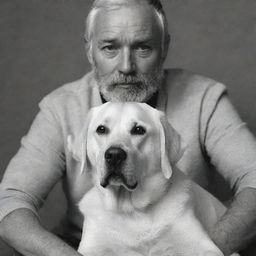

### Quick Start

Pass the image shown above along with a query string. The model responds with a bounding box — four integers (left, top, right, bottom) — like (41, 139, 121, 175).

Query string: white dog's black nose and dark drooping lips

(100, 147, 137, 190)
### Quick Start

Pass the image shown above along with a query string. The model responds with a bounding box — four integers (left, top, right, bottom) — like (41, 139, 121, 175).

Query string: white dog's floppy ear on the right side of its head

(160, 114, 185, 179)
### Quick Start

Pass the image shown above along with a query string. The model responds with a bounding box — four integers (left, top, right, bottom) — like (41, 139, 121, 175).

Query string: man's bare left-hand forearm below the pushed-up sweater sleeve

(0, 209, 81, 256)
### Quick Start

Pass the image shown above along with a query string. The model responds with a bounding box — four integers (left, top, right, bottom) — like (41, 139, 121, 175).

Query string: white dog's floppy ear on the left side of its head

(67, 111, 91, 174)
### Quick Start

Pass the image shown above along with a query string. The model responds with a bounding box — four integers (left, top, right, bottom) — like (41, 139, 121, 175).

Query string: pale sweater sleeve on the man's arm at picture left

(0, 97, 65, 220)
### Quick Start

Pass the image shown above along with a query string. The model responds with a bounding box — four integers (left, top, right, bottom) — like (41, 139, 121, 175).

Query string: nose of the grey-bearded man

(118, 48, 135, 74)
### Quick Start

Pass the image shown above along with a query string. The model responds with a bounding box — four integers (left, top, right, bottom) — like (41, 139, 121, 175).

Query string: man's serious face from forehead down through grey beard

(89, 4, 166, 102)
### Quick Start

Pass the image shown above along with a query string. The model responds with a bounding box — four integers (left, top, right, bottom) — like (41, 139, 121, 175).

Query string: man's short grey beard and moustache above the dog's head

(93, 66, 164, 102)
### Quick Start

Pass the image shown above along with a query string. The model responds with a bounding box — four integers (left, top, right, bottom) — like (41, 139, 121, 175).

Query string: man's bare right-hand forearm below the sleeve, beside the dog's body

(211, 188, 256, 256)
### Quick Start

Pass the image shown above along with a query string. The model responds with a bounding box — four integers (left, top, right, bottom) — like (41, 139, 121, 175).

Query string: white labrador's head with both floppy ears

(69, 103, 183, 208)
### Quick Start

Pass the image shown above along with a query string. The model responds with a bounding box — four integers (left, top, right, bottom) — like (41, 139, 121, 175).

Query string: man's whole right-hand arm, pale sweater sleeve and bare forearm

(201, 84, 256, 255)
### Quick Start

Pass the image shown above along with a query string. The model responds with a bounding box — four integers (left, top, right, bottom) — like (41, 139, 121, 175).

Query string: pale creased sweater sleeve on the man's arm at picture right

(201, 84, 256, 193)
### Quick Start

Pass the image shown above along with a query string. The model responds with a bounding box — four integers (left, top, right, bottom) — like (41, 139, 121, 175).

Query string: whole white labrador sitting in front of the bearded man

(68, 103, 238, 256)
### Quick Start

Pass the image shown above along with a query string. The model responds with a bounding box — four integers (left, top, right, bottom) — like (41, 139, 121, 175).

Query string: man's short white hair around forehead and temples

(85, 0, 170, 58)
